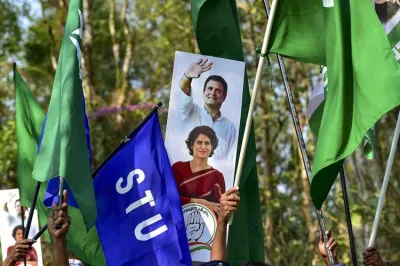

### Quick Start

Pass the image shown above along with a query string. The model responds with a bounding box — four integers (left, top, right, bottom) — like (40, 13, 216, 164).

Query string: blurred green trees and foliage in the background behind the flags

(0, 0, 400, 265)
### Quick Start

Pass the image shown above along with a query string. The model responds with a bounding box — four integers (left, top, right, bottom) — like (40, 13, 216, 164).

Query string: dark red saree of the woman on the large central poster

(172, 162, 225, 205)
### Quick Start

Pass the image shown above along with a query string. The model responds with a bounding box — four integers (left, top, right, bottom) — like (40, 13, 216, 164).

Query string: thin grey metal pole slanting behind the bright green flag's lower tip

(264, 0, 335, 266)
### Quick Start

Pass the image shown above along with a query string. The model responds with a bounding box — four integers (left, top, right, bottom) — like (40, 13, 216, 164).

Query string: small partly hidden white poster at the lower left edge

(0, 189, 43, 266)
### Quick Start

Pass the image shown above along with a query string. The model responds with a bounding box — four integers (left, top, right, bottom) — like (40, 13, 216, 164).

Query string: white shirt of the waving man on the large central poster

(176, 89, 236, 160)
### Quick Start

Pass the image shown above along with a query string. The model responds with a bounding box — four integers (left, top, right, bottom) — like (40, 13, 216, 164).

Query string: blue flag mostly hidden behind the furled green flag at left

(38, 94, 92, 209)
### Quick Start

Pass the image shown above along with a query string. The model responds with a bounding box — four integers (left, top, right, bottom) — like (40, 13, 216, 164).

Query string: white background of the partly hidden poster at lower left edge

(0, 189, 43, 266)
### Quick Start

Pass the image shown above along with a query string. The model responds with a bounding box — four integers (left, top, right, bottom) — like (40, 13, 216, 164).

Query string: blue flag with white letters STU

(94, 113, 192, 266)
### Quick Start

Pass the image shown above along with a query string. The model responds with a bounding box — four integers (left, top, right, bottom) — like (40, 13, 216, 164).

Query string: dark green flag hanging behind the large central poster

(192, 0, 264, 265)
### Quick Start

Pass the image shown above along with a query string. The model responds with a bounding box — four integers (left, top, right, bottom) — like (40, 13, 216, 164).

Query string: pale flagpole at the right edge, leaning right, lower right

(368, 112, 400, 247)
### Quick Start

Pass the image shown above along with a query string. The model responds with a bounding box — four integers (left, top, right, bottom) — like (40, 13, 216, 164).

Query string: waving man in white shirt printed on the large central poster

(176, 59, 236, 160)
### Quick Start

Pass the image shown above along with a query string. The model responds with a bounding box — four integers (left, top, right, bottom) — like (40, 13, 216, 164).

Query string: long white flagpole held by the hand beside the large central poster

(229, 0, 278, 225)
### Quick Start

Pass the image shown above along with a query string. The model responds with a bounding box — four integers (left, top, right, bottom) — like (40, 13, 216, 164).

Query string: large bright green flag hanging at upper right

(270, 0, 400, 209)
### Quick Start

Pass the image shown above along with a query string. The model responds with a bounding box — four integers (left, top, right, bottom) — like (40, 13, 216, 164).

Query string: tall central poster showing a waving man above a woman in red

(165, 52, 245, 262)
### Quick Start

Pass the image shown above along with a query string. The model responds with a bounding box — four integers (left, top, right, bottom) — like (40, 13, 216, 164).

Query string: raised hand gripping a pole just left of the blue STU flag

(47, 190, 71, 241)
